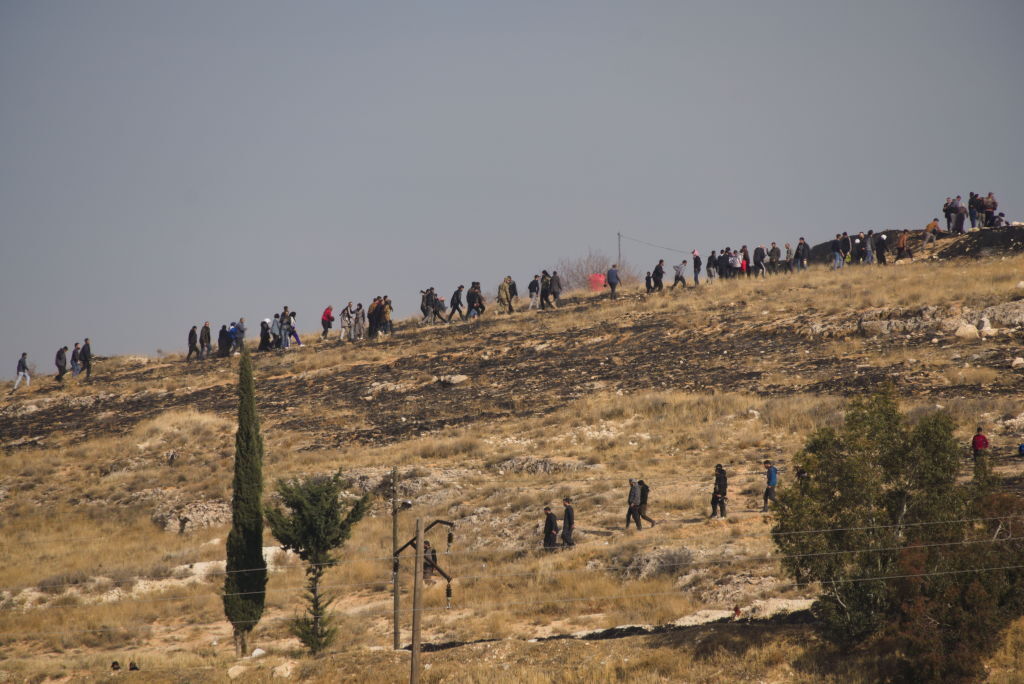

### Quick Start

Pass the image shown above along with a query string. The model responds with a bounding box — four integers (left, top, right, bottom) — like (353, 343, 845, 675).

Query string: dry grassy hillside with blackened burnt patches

(0, 228, 1024, 682)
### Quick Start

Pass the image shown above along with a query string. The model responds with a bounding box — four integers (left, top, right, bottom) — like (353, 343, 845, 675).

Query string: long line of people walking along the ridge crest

(12, 193, 1007, 391)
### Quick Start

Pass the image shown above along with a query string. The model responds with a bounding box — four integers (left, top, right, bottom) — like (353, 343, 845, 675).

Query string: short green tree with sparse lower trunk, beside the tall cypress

(266, 473, 371, 654)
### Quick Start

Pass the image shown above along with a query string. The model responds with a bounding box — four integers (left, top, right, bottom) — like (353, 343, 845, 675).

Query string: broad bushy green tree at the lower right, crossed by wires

(773, 387, 1024, 681)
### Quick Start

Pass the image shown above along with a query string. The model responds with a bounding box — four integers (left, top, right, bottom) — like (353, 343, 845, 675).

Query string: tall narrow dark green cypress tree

(223, 348, 266, 656)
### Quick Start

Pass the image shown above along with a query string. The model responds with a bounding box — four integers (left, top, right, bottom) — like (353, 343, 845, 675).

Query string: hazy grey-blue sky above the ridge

(0, 0, 1024, 368)
